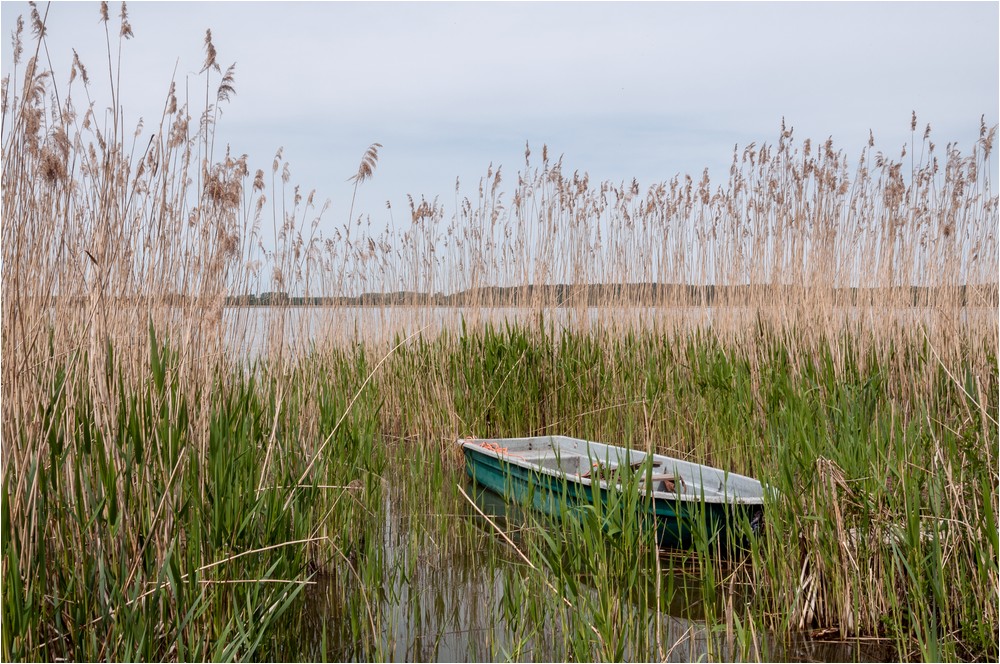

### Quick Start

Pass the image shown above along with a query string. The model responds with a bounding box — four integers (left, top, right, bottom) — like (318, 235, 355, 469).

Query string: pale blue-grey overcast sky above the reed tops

(2, 2, 1000, 233)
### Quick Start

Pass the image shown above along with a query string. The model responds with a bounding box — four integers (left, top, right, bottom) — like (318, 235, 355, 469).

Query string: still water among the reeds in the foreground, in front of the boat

(296, 446, 897, 662)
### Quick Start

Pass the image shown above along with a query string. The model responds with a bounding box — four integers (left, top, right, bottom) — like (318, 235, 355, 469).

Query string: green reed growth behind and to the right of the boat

(381, 328, 997, 659)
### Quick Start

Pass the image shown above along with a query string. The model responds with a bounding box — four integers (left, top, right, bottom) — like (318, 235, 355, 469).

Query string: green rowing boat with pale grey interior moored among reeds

(457, 436, 764, 548)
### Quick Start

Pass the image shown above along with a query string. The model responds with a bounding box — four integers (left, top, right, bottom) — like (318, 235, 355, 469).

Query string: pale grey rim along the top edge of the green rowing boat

(456, 435, 766, 506)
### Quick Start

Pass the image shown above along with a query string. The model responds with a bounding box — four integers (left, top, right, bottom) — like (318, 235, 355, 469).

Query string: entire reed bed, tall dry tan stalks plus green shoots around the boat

(0, 3, 1000, 659)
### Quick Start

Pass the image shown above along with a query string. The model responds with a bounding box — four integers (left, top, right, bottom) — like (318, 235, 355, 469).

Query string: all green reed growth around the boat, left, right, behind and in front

(4, 326, 997, 659)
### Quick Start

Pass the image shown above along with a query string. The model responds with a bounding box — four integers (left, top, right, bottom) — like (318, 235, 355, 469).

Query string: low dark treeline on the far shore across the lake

(221, 283, 1000, 307)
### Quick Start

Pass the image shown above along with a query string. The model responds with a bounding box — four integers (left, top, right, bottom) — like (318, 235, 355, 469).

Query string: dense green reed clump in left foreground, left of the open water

(3, 330, 390, 660)
